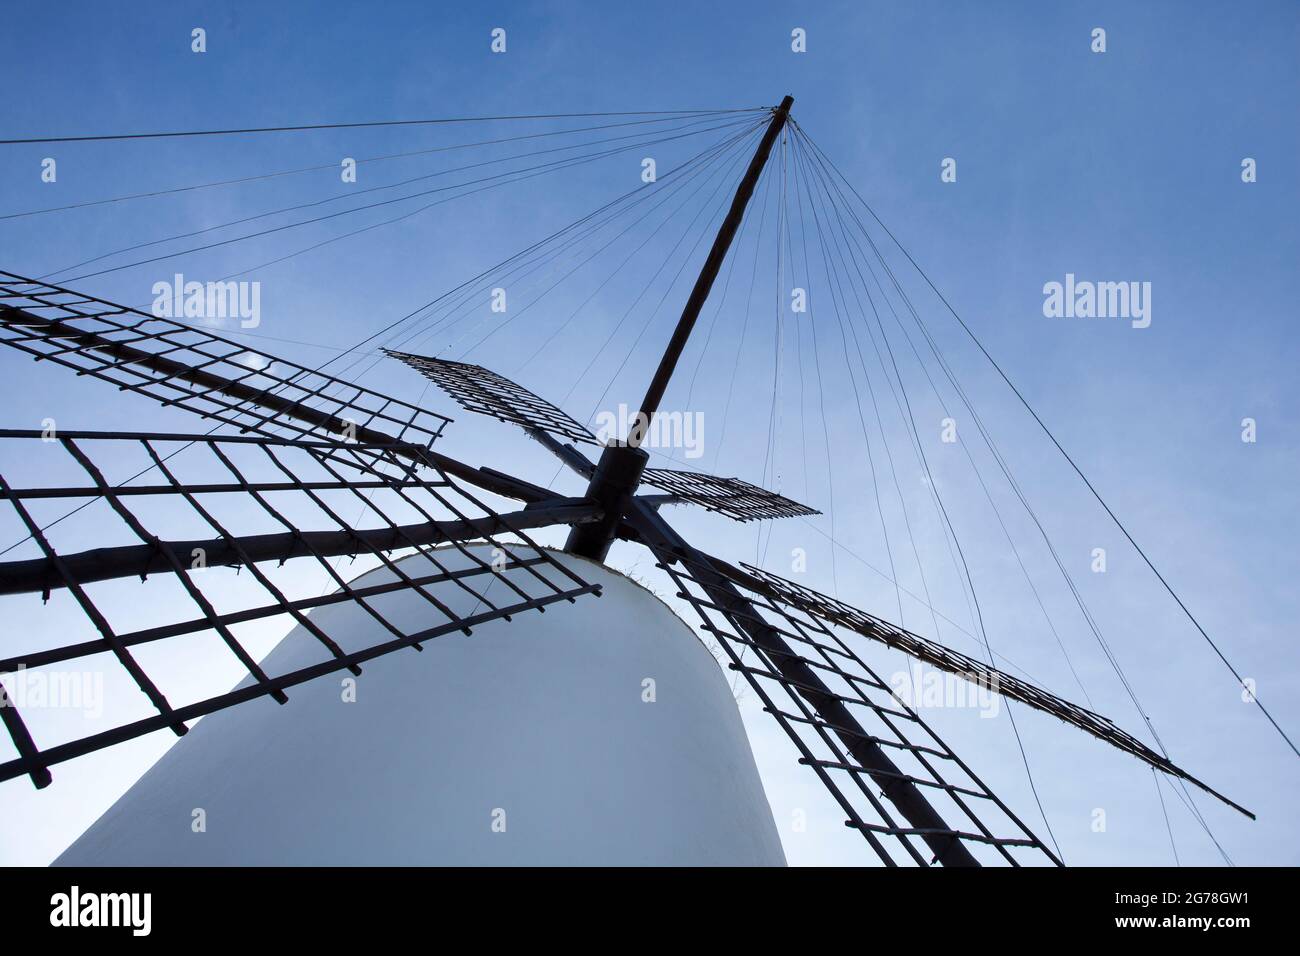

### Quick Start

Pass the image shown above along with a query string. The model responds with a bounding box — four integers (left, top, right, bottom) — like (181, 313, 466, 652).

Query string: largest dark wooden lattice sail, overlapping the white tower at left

(0, 431, 599, 787)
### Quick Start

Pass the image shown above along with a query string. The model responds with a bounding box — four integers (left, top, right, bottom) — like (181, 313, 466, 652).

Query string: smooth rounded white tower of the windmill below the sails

(55, 549, 785, 865)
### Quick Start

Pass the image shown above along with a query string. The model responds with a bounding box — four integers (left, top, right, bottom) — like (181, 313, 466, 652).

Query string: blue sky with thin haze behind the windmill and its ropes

(0, 3, 1300, 864)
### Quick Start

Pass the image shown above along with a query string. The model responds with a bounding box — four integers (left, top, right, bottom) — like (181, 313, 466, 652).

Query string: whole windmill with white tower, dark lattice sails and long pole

(0, 96, 1249, 866)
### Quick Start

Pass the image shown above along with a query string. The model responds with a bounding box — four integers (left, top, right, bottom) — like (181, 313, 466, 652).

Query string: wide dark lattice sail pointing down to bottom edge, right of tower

(633, 506, 1061, 866)
